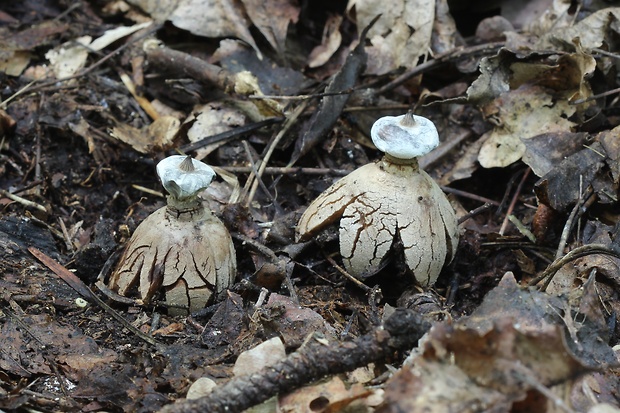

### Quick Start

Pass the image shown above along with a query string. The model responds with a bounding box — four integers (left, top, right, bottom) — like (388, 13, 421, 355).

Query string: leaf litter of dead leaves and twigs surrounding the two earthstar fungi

(0, 0, 620, 412)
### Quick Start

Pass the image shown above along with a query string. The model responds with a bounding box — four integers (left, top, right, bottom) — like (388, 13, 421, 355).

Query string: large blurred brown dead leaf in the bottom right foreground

(379, 273, 613, 412)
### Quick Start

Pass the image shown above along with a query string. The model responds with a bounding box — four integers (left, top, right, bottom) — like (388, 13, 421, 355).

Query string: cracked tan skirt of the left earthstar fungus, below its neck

(109, 207, 236, 311)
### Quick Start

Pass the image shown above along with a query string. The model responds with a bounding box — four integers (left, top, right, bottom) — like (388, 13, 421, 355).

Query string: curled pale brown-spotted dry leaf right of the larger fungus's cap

(467, 50, 596, 168)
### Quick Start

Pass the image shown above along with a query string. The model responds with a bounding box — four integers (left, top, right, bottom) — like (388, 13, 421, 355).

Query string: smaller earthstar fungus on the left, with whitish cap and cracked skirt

(109, 155, 237, 314)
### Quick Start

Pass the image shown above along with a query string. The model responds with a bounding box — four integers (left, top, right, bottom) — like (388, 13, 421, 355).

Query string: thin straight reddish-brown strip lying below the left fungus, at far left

(28, 247, 161, 346)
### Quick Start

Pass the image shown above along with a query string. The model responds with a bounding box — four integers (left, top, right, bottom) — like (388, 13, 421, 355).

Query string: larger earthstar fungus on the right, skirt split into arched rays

(297, 113, 458, 286)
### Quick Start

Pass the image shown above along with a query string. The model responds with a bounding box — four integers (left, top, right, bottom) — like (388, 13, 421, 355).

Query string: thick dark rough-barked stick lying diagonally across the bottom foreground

(160, 308, 430, 413)
